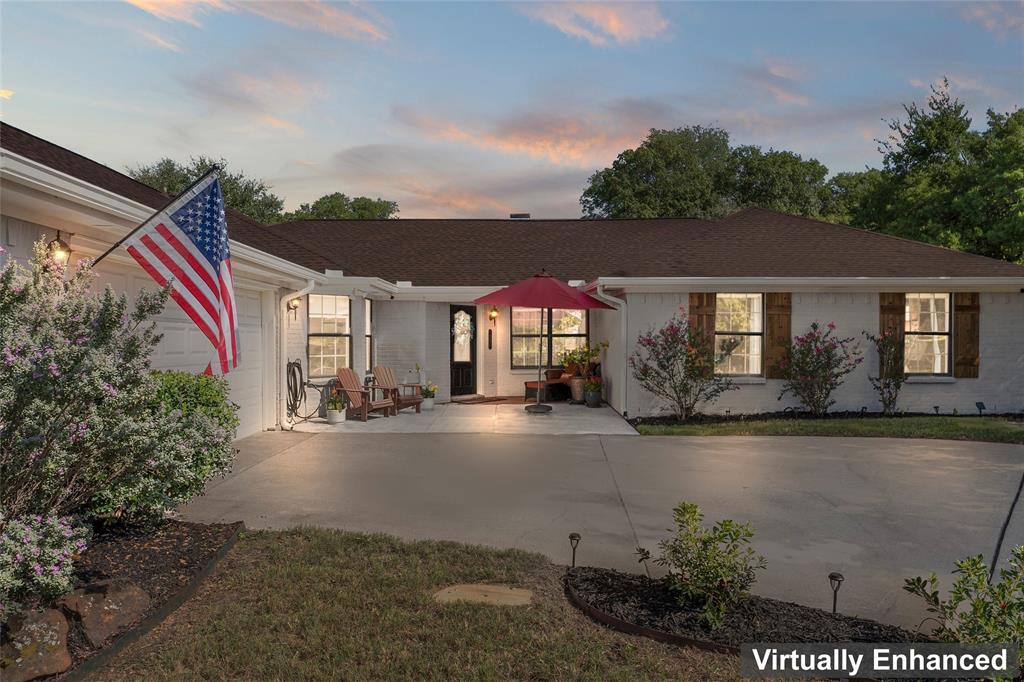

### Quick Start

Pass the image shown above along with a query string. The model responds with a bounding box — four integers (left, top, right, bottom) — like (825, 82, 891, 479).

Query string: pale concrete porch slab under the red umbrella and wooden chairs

(295, 402, 637, 435)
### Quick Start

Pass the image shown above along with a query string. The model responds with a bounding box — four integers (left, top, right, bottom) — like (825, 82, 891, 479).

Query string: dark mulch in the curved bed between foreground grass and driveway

(566, 566, 930, 646)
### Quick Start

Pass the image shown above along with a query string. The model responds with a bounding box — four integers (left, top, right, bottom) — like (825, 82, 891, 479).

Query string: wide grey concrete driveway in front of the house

(183, 432, 1024, 627)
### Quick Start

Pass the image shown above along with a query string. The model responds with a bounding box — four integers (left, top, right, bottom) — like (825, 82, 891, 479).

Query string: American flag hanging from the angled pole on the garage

(125, 172, 239, 374)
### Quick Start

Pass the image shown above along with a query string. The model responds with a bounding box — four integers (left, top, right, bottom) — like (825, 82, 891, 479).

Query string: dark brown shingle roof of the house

(0, 123, 1024, 286)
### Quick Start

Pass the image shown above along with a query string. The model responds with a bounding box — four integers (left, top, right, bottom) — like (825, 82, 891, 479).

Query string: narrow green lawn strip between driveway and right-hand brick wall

(637, 417, 1024, 443)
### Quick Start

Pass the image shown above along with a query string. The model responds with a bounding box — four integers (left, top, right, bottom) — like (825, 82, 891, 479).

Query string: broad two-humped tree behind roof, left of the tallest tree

(580, 126, 829, 218)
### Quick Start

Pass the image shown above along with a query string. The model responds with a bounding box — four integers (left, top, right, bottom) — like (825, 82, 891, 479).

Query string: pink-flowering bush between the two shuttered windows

(777, 322, 864, 417)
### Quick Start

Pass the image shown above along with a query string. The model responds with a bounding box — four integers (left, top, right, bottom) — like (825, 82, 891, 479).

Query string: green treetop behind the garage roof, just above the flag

(128, 156, 285, 223)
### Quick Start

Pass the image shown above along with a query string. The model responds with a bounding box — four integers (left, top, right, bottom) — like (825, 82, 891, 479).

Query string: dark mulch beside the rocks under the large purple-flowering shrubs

(68, 519, 239, 670)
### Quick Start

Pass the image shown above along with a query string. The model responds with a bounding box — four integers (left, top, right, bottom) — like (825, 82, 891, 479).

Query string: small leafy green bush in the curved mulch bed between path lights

(637, 502, 766, 630)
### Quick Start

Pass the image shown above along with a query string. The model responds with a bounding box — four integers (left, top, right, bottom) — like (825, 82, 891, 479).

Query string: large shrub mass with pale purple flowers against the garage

(0, 242, 233, 532)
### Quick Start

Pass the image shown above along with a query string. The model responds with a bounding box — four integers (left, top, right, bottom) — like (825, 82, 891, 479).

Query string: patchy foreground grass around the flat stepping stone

(93, 529, 738, 682)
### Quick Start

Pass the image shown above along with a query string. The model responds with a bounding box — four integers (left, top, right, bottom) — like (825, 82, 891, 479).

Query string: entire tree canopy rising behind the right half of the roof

(580, 81, 1024, 263)
